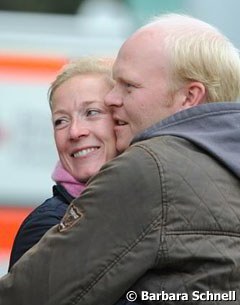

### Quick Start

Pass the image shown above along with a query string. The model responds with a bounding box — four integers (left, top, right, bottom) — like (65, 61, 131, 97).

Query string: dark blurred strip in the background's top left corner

(0, 0, 84, 14)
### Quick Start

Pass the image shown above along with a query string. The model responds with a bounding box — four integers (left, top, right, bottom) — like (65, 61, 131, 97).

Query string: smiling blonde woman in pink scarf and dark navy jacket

(9, 57, 117, 270)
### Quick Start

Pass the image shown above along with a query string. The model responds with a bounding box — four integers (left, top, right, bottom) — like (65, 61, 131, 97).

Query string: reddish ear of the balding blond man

(182, 82, 207, 109)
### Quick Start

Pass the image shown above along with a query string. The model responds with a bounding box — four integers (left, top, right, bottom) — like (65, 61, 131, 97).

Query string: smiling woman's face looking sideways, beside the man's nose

(52, 74, 117, 182)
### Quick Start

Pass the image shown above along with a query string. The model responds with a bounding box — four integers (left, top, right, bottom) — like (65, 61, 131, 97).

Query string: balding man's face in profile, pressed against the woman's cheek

(105, 30, 184, 152)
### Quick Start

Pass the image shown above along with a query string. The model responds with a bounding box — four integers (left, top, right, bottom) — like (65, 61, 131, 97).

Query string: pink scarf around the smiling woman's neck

(52, 161, 86, 198)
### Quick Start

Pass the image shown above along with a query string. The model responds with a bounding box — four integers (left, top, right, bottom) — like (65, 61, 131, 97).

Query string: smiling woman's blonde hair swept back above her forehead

(48, 56, 115, 108)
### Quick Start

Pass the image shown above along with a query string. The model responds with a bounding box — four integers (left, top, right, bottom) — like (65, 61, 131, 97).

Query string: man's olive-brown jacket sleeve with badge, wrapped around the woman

(0, 147, 162, 305)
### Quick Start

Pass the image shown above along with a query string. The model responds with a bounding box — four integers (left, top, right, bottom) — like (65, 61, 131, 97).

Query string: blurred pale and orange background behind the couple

(0, 0, 240, 276)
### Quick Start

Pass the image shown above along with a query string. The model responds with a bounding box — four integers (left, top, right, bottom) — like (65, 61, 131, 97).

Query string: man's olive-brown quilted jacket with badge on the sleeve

(0, 101, 240, 305)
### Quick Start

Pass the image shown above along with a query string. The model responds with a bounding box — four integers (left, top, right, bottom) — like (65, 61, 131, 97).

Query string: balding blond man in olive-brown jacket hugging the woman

(0, 15, 240, 305)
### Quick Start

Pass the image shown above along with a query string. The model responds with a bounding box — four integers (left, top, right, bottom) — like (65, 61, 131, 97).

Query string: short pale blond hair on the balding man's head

(147, 14, 240, 102)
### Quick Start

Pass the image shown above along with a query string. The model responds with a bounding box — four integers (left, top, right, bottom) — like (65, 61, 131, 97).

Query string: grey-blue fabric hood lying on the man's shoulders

(132, 102, 240, 178)
